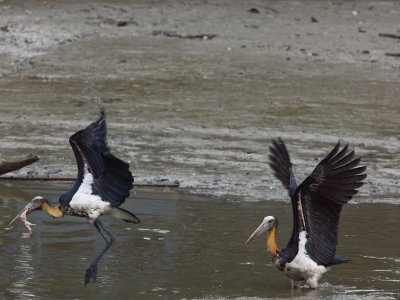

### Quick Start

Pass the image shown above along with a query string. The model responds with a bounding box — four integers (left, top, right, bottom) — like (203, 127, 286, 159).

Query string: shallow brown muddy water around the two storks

(0, 183, 400, 299)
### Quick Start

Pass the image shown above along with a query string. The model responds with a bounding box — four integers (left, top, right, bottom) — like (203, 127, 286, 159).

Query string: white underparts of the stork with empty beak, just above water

(283, 231, 328, 288)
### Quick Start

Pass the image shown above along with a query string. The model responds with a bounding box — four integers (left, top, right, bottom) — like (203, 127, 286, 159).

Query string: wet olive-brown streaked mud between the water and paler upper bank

(0, 39, 400, 203)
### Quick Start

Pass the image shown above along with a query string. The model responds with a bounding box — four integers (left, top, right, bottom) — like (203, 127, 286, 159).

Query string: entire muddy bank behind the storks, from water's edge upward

(0, 1, 400, 203)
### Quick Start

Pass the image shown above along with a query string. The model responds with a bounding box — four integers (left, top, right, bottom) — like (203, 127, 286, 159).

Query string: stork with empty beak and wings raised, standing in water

(246, 138, 367, 288)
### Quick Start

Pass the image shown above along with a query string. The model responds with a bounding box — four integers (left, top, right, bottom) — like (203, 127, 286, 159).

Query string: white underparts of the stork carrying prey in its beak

(69, 163, 110, 219)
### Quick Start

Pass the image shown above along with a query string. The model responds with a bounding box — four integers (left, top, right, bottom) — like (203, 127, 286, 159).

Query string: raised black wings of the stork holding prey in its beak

(60, 110, 133, 206)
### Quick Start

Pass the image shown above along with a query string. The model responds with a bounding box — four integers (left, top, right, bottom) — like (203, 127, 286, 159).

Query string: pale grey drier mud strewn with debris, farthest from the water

(0, 0, 400, 73)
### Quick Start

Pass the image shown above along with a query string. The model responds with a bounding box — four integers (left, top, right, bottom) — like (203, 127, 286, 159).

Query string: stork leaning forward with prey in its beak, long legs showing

(9, 110, 140, 286)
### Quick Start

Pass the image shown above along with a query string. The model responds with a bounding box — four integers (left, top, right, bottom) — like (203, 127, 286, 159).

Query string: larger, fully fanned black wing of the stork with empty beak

(295, 142, 367, 266)
